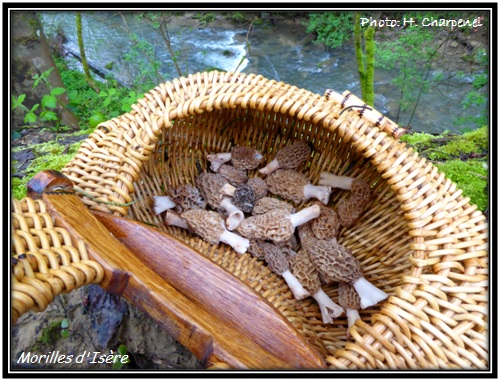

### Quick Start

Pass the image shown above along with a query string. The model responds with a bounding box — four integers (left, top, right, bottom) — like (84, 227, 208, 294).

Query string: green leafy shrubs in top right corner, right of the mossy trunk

(376, 12, 489, 128)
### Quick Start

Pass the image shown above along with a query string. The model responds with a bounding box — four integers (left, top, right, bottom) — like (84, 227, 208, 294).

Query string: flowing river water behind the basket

(42, 12, 481, 133)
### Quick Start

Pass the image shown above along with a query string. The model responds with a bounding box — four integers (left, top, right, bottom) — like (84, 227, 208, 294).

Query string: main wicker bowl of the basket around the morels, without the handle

(12, 71, 489, 369)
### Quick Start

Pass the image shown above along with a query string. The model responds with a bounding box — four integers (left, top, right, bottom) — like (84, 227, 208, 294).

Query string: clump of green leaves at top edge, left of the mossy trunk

(306, 12, 354, 49)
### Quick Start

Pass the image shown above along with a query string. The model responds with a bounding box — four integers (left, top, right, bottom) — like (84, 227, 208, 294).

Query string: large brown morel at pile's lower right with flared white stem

(299, 224, 388, 308)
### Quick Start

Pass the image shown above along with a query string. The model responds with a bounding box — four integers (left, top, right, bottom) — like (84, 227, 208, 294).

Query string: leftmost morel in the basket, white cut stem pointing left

(153, 184, 207, 215)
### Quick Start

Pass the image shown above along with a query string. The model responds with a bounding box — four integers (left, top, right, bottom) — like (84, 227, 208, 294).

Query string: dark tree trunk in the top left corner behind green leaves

(10, 12, 78, 130)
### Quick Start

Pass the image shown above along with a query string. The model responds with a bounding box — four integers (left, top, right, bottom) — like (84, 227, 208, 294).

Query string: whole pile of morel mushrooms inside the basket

(153, 141, 387, 335)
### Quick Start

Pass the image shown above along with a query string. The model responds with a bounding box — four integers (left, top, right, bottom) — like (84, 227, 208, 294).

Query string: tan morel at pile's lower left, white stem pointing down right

(181, 209, 250, 254)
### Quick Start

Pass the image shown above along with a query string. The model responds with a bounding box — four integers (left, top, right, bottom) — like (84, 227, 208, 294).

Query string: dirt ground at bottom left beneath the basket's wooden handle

(11, 285, 203, 370)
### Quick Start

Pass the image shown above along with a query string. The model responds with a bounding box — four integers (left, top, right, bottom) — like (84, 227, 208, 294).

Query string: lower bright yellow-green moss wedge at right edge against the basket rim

(436, 160, 488, 211)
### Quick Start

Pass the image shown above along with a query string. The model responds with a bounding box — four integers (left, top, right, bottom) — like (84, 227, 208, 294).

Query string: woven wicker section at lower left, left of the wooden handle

(11, 198, 104, 324)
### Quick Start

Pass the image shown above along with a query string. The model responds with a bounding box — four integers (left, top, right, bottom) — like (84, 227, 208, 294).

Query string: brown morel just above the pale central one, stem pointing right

(266, 169, 331, 205)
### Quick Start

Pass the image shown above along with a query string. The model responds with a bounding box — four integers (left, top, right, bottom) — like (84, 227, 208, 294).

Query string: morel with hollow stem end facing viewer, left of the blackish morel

(196, 172, 245, 230)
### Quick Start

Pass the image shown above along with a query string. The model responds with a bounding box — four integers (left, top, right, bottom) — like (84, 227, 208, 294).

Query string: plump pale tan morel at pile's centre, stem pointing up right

(237, 205, 320, 242)
